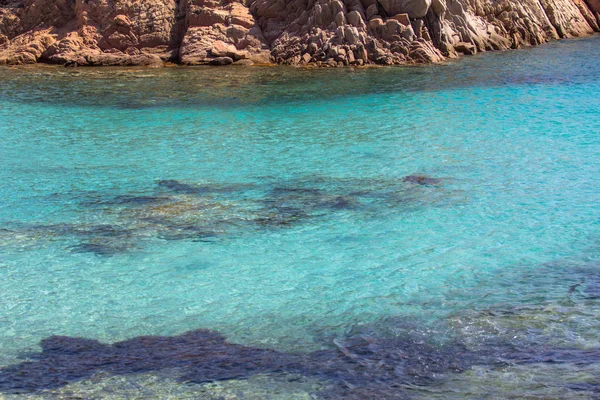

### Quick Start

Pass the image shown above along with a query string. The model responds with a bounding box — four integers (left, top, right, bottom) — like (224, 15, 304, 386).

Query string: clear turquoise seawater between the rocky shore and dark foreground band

(0, 37, 600, 398)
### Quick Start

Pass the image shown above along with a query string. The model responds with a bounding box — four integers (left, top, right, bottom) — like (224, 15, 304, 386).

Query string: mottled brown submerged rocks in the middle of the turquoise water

(0, 175, 452, 257)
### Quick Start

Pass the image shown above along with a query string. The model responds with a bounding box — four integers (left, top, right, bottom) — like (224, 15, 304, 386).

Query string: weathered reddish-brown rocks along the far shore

(0, 0, 600, 66)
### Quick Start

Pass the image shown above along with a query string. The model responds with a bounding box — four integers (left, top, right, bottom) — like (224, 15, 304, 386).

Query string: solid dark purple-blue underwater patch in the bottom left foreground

(0, 330, 288, 393)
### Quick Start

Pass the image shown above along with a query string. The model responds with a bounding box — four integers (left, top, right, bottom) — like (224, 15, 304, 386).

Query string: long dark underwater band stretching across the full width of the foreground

(0, 320, 600, 399)
